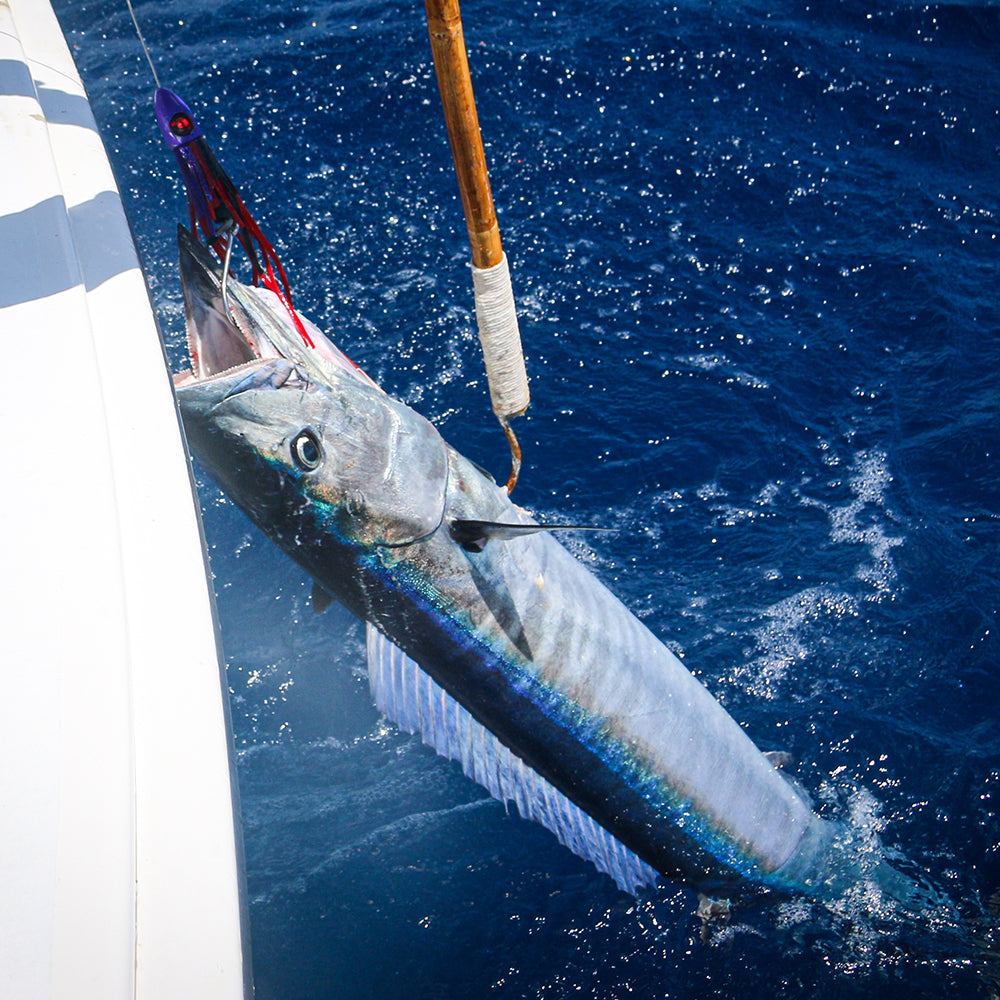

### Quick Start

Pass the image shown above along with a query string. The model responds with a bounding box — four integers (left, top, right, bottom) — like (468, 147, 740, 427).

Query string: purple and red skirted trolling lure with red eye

(153, 87, 316, 347)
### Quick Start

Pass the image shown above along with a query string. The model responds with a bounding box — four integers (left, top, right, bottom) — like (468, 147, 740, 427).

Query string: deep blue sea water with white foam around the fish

(56, 0, 1000, 1000)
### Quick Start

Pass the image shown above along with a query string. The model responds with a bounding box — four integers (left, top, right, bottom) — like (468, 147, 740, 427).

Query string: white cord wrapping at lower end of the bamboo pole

(472, 254, 530, 424)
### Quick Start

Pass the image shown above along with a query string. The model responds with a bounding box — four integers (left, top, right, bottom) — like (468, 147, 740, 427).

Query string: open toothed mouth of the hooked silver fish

(173, 225, 375, 390)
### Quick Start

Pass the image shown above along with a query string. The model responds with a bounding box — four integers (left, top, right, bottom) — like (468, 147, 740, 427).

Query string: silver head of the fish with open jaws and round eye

(174, 231, 448, 562)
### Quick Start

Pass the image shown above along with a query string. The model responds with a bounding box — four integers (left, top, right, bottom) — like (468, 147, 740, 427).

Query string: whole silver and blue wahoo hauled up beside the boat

(175, 228, 909, 899)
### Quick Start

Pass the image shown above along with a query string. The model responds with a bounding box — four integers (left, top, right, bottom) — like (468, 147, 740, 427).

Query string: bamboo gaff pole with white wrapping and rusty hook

(425, 0, 530, 493)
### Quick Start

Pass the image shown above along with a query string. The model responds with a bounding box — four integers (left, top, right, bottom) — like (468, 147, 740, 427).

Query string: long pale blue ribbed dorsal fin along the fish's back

(367, 623, 657, 895)
